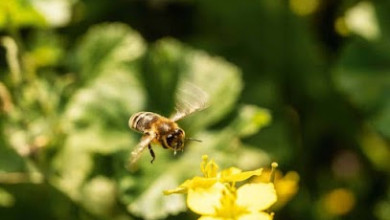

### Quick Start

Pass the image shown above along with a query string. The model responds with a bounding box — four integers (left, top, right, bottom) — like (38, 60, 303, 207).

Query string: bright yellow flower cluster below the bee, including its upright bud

(164, 156, 276, 220)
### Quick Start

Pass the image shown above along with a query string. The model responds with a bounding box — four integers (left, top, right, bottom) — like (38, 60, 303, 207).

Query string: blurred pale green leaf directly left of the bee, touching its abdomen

(65, 68, 145, 131)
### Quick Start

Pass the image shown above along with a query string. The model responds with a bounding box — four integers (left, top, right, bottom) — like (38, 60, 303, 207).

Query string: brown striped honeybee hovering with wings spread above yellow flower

(129, 84, 207, 167)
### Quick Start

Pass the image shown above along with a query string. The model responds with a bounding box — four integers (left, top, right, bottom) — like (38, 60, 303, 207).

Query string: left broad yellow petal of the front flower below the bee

(187, 182, 225, 215)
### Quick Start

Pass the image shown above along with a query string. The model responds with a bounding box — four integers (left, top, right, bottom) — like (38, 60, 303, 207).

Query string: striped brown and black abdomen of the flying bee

(129, 112, 162, 133)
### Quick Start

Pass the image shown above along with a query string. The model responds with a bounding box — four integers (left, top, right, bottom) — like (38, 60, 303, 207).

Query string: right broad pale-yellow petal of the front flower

(236, 183, 276, 211)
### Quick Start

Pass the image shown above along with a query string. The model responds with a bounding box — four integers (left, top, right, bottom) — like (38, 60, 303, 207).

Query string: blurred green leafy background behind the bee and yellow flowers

(0, 0, 390, 220)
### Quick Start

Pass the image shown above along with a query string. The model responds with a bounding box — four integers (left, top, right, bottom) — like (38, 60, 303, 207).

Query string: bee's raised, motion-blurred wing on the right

(170, 83, 208, 121)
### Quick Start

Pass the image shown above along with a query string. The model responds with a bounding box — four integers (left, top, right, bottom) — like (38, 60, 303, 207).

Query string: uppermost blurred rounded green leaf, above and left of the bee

(76, 23, 146, 80)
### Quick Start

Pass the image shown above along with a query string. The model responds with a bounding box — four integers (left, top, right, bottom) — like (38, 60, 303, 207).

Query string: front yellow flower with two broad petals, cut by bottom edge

(192, 183, 276, 220)
